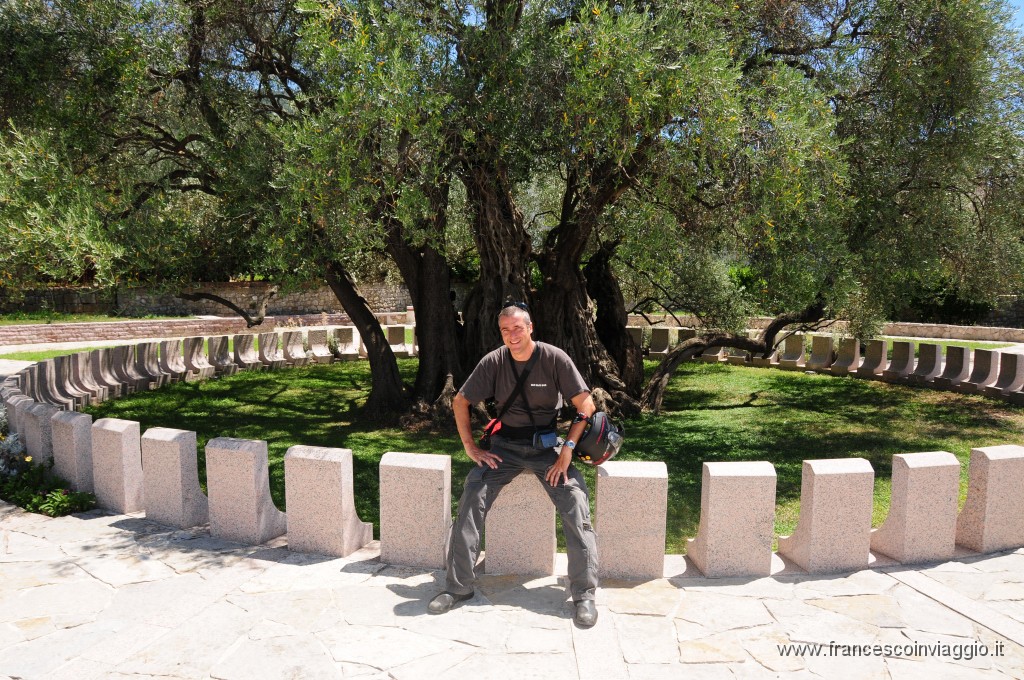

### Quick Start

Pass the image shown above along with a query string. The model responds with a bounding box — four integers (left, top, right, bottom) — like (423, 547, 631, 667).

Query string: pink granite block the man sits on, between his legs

(483, 472, 557, 576)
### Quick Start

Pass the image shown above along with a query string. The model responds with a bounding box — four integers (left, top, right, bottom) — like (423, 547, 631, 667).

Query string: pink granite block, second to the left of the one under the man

(285, 447, 374, 557)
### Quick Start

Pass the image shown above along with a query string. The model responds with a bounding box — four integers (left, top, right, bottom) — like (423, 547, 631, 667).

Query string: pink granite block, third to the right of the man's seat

(778, 458, 874, 573)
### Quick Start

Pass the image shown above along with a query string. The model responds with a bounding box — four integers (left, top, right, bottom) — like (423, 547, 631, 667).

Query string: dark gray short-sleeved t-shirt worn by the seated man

(459, 342, 590, 427)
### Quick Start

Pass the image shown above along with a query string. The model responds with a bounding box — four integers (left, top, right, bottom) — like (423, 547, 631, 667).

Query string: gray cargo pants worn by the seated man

(445, 435, 597, 602)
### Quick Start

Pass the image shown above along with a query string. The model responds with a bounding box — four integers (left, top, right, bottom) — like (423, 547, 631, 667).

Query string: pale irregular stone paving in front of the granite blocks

(0, 504, 1024, 680)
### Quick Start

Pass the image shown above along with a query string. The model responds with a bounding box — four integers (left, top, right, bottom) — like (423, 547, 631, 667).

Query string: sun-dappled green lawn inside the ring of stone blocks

(81, 359, 1024, 553)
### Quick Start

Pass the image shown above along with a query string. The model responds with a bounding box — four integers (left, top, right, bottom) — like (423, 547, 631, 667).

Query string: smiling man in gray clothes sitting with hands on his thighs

(428, 303, 597, 628)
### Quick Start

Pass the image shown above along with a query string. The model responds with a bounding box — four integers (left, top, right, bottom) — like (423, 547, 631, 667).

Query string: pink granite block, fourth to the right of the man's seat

(871, 451, 959, 564)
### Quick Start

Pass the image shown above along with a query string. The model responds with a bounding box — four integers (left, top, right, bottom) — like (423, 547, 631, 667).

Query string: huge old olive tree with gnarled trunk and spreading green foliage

(0, 0, 1022, 413)
